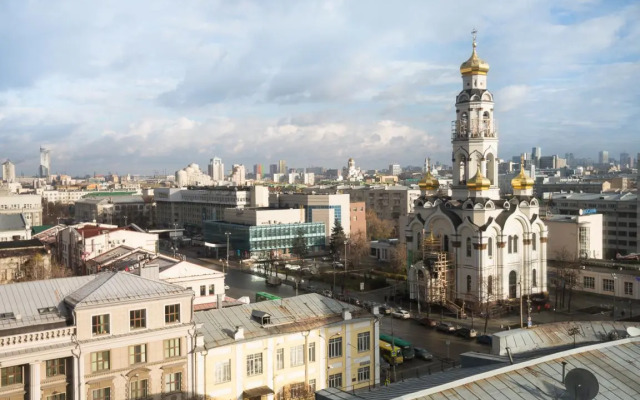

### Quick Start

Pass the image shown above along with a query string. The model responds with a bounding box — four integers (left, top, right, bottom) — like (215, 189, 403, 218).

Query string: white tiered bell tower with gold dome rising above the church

(451, 29, 500, 200)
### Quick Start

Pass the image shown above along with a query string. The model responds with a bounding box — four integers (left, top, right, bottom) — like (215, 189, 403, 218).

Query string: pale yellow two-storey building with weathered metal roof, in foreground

(194, 294, 380, 400)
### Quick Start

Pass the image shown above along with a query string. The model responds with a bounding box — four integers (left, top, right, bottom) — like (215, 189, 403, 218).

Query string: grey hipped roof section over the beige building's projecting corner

(65, 272, 191, 307)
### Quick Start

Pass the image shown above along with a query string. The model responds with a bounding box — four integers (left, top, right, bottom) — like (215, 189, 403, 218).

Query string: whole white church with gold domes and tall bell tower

(405, 31, 547, 307)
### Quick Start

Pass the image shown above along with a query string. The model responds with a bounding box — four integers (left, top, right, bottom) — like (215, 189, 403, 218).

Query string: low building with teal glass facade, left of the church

(204, 221, 326, 257)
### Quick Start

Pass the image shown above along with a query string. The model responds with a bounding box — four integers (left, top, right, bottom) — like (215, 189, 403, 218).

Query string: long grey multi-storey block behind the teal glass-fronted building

(154, 186, 269, 228)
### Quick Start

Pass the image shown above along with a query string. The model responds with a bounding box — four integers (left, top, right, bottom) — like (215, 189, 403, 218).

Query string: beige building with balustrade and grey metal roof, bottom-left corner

(0, 272, 195, 400)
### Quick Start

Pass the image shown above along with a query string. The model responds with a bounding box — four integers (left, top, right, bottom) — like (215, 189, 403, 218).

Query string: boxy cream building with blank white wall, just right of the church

(544, 214, 602, 261)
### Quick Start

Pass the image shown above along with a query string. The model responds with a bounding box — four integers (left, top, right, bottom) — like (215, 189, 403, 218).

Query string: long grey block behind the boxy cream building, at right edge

(549, 190, 640, 258)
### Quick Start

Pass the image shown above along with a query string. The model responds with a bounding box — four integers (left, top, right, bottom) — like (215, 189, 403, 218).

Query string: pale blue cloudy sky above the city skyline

(0, 0, 640, 176)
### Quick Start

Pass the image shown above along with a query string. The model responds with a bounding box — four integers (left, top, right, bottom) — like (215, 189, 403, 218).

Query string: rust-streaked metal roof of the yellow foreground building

(194, 293, 364, 348)
